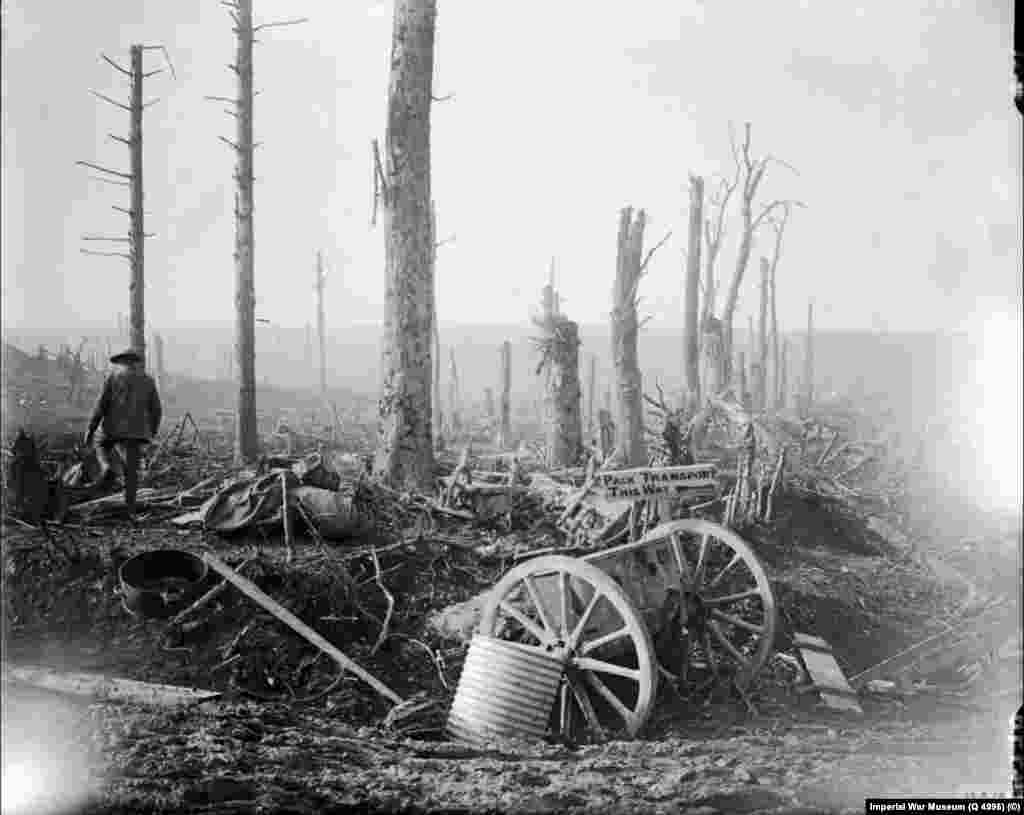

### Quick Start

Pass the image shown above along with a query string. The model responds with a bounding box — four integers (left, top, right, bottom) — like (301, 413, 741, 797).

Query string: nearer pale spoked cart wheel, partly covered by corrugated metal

(479, 555, 657, 738)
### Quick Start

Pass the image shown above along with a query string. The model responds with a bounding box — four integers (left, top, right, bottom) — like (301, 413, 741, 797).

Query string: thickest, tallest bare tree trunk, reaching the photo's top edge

(375, 0, 437, 488)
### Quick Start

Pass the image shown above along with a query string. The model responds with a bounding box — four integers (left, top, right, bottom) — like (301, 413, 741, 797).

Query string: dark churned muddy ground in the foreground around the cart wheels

(3, 477, 1021, 815)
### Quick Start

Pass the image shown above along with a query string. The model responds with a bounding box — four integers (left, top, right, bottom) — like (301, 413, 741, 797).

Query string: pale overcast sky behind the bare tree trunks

(2, 0, 1022, 337)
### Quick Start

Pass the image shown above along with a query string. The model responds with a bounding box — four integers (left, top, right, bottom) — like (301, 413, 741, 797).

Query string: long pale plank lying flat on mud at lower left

(3, 666, 221, 707)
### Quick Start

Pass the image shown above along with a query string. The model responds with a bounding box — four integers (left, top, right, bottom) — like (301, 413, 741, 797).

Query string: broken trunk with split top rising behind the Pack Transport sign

(611, 207, 647, 467)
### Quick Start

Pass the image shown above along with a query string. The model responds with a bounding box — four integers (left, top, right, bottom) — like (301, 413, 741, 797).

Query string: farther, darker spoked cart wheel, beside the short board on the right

(638, 519, 775, 688)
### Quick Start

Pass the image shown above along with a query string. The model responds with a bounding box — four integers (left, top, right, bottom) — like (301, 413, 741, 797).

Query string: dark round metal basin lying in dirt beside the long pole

(118, 549, 207, 619)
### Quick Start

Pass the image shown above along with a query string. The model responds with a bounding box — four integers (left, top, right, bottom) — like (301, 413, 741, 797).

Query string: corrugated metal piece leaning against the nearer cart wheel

(447, 634, 564, 742)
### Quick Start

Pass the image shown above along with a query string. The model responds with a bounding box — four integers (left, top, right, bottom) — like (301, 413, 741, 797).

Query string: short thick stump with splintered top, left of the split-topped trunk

(544, 313, 583, 469)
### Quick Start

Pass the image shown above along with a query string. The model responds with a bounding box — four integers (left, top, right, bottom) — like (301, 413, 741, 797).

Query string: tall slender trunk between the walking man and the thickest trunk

(234, 0, 259, 463)
